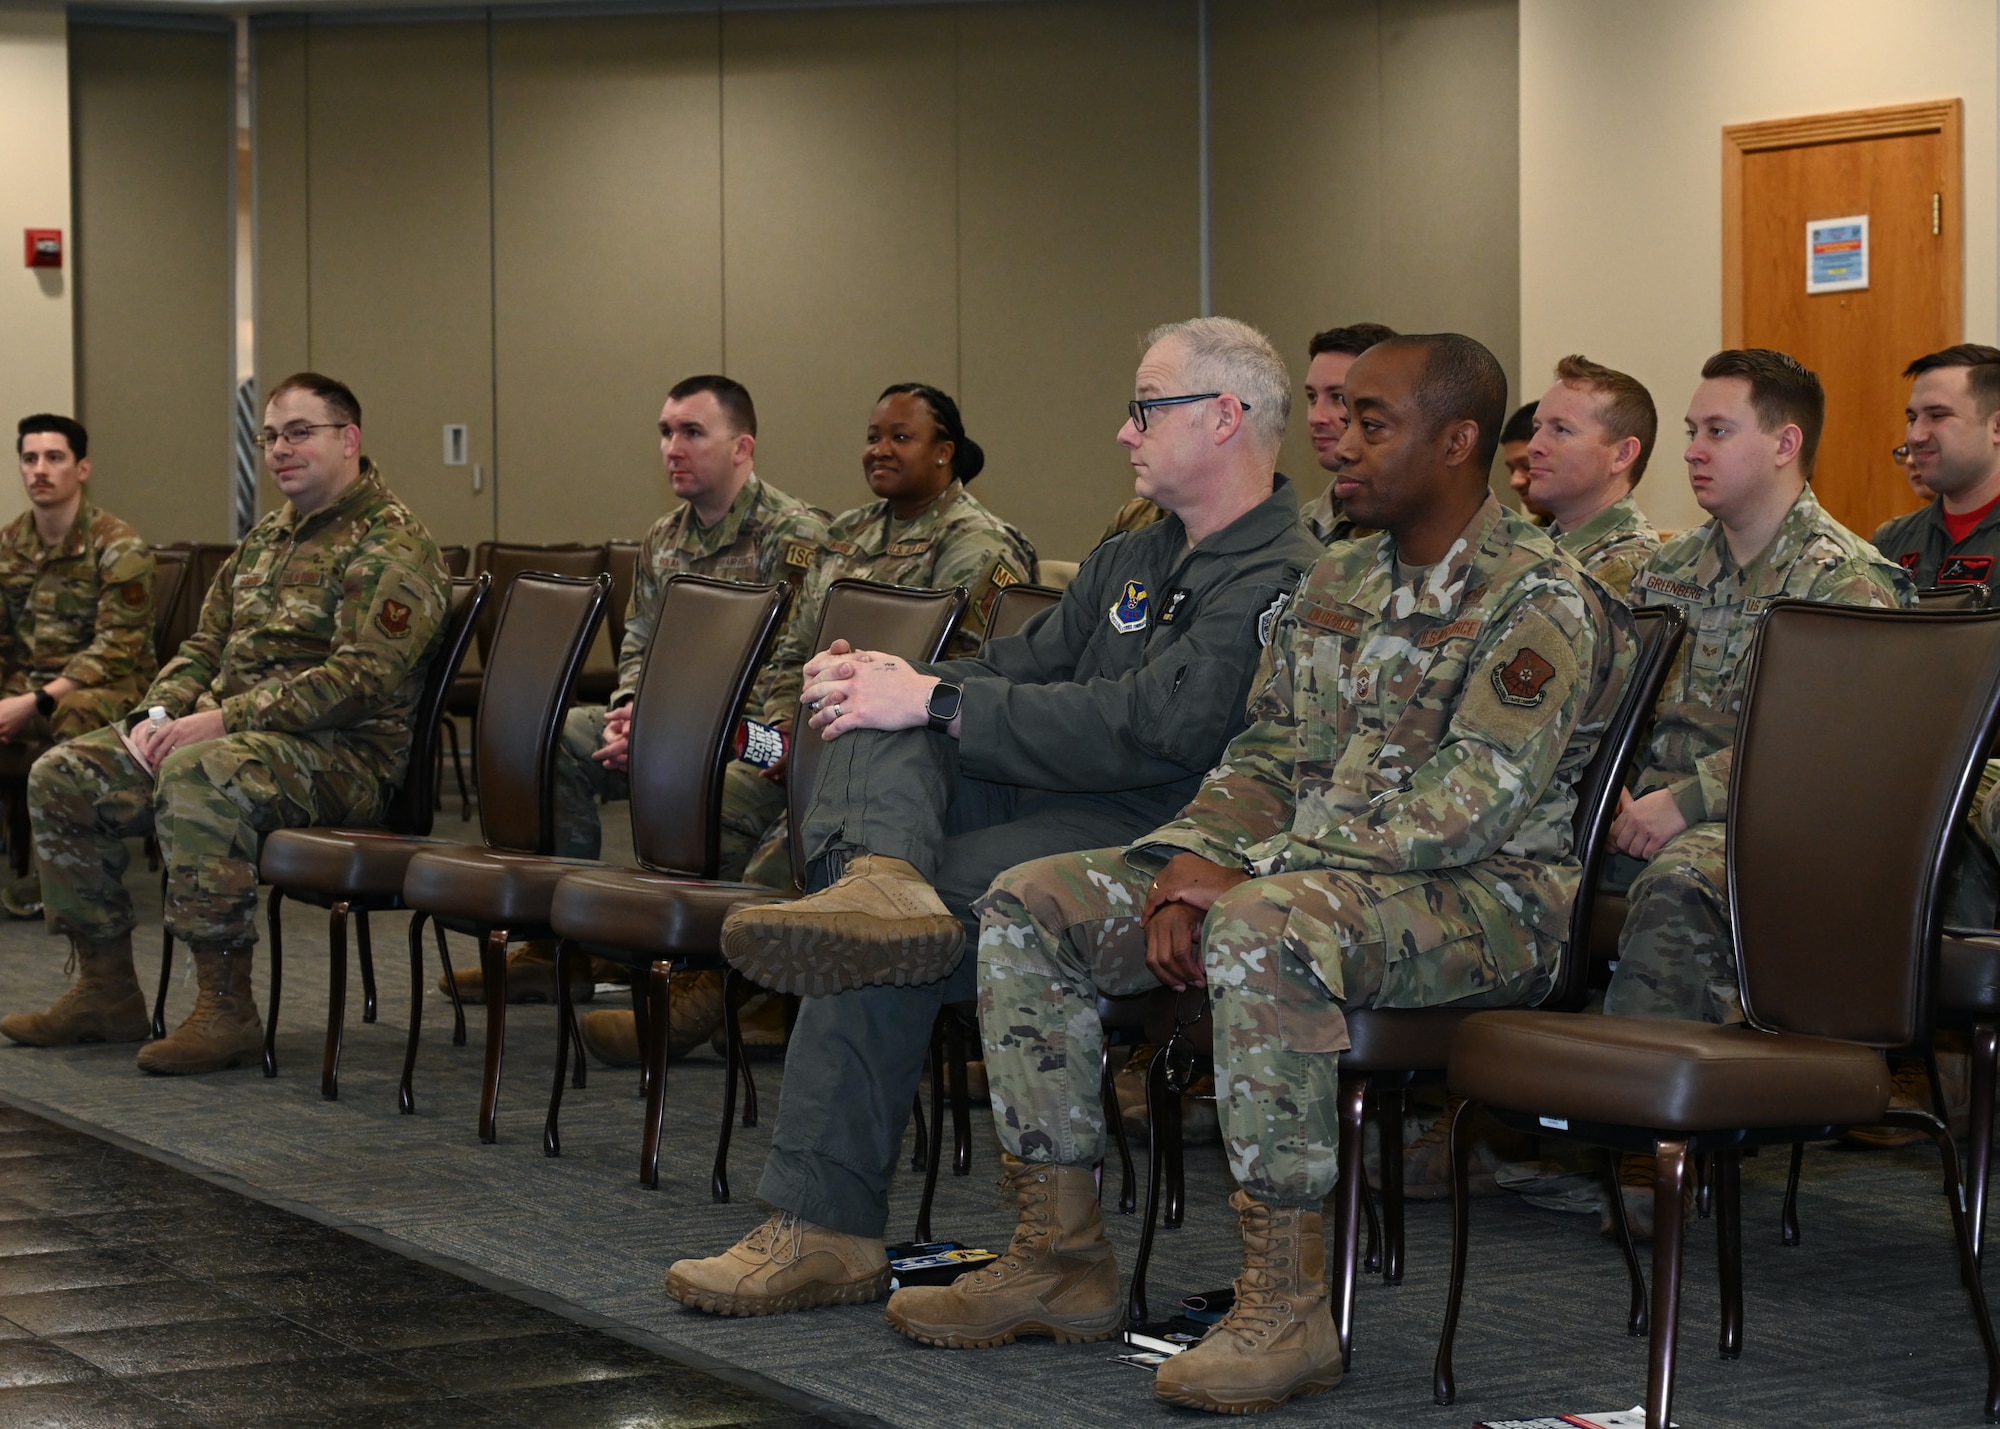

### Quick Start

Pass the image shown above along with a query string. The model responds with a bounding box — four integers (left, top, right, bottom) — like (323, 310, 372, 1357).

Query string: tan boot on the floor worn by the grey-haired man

(666, 1211, 888, 1315)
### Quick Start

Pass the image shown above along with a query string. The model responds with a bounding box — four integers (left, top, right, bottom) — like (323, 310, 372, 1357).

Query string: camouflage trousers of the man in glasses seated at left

(28, 729, 390, 949)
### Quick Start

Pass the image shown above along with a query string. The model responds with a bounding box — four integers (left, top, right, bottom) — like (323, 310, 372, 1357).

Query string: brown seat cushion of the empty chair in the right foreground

(1450, 1011, 1890, 1131)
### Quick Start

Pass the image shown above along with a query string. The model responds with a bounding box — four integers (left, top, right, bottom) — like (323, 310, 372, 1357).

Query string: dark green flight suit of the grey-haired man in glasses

(758, 478, 1318, 1237)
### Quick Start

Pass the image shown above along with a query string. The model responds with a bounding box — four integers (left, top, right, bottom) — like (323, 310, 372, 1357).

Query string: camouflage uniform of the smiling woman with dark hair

(722, 480, 1040, 889)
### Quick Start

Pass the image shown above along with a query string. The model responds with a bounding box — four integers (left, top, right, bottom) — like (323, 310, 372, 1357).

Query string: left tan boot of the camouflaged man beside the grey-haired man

(888, 1155, 1124, 1349)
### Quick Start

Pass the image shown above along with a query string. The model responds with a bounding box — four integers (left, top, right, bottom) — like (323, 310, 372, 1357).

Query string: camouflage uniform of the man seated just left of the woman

(556, 472, 826, 856)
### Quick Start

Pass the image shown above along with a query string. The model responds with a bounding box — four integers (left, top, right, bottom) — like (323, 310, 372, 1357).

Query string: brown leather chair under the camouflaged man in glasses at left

(258, 574, 492, 1088)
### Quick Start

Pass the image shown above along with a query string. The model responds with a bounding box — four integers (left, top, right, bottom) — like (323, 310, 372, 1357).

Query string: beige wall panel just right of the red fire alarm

(70, 22, 236, 540)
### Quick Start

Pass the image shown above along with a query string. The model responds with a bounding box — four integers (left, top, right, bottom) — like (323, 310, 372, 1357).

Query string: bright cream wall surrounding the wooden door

(1520, 0, 2000, 528)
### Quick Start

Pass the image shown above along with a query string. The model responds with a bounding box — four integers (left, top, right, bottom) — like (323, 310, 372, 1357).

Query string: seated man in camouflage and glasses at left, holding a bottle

(0, 372, 450, 1073)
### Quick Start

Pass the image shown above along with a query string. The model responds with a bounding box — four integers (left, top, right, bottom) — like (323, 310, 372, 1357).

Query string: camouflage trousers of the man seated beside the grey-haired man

(976, 849, 1560, 1207)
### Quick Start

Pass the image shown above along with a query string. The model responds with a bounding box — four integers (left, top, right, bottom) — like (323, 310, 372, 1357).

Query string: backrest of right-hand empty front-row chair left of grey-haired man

(630, 574, 792, 879)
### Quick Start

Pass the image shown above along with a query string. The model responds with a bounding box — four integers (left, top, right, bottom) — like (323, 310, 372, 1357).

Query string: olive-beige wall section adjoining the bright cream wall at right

(1210, 0, 1520, 494)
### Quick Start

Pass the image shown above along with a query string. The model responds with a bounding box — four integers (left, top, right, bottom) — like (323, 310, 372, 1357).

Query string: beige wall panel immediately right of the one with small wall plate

(494, 14, 724, 540)
